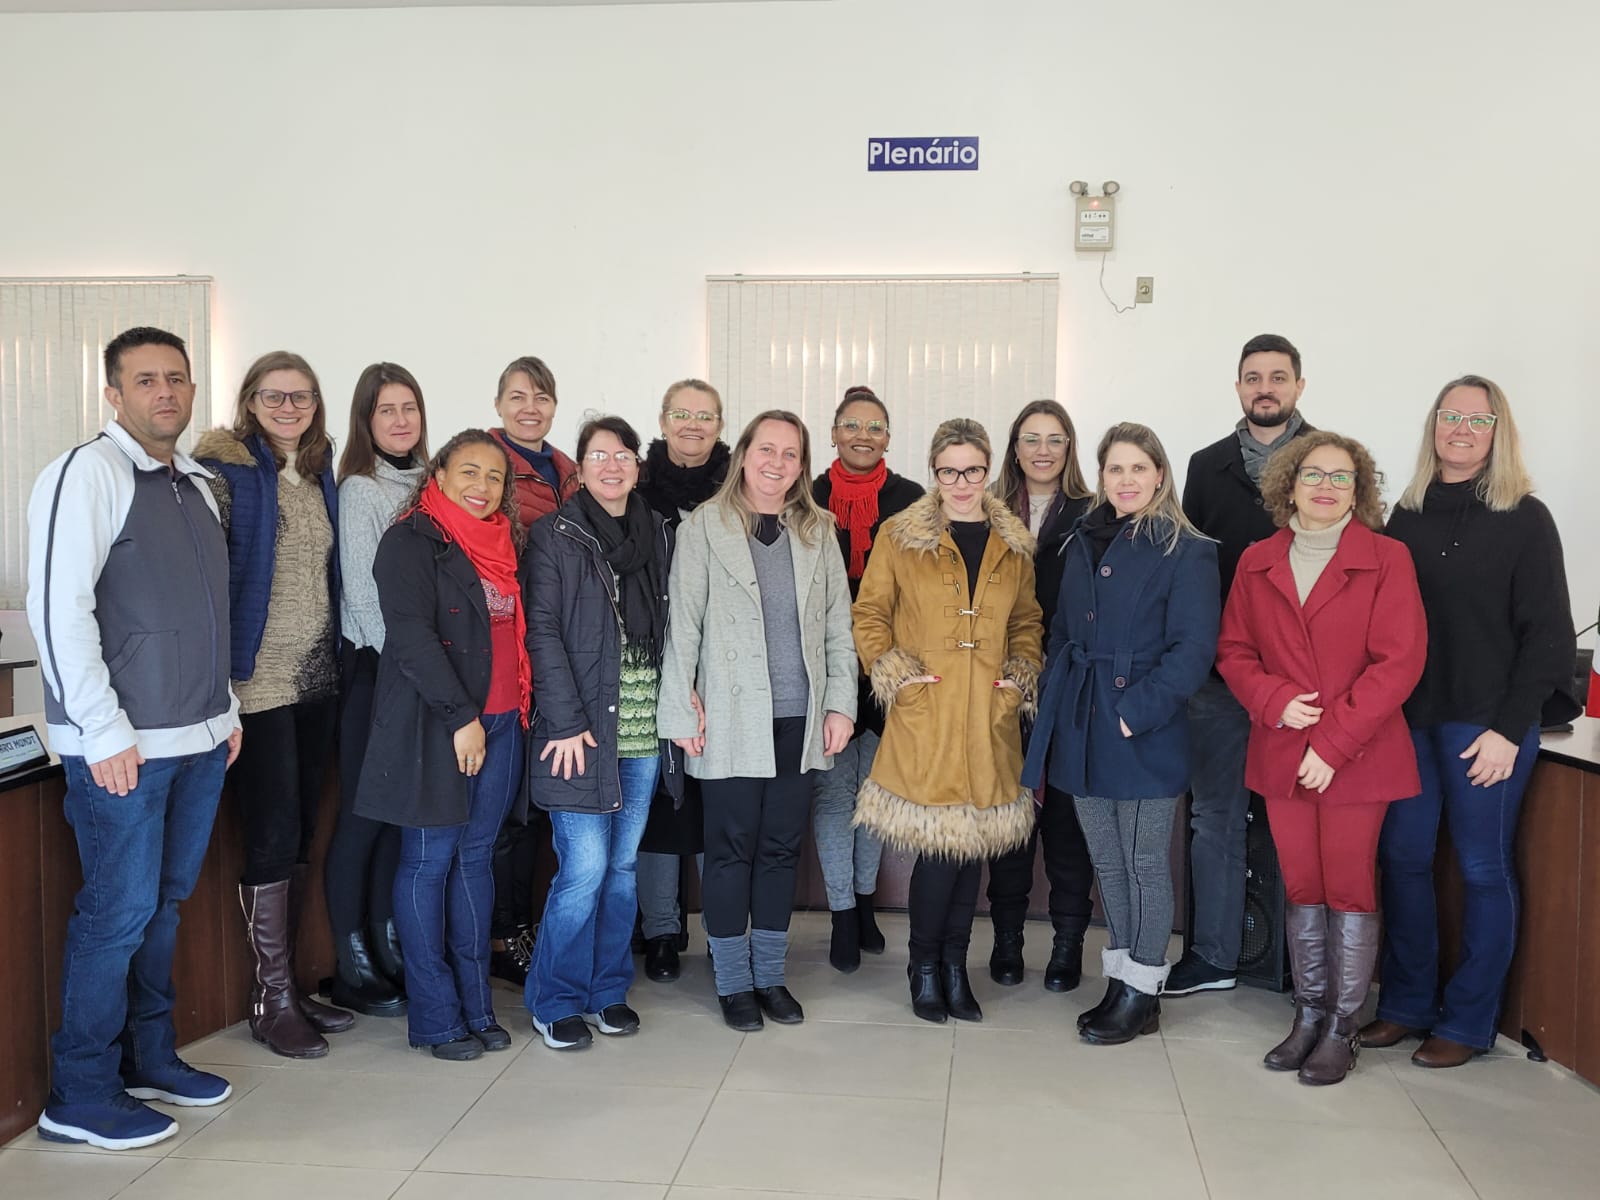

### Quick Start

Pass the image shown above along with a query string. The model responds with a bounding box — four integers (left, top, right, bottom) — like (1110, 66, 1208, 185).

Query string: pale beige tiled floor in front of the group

(0, 914, 1600, 1200)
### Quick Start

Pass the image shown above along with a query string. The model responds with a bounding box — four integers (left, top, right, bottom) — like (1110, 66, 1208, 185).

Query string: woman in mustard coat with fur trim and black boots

(851, 418, 1043, 1021)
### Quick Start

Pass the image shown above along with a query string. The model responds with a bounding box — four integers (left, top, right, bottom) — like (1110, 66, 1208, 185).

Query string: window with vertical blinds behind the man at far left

(0, 277, 211, 608)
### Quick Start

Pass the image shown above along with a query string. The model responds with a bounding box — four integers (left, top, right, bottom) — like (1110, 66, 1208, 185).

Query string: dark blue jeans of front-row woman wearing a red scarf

(394, 710, 522, 1046)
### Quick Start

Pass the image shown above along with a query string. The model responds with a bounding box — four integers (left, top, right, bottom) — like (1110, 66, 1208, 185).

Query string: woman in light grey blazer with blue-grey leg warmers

(656, 411, 856, 1032)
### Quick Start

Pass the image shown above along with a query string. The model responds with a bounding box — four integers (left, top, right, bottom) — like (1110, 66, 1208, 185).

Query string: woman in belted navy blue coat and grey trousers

(1022, 424, 1221, 1045)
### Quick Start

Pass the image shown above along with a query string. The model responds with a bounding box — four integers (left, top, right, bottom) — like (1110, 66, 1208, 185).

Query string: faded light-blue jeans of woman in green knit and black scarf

(523, 755, 661, 1026)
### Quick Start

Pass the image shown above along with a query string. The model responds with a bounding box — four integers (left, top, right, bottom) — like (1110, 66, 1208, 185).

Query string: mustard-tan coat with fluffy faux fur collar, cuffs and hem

(851, 494, 1043, 859)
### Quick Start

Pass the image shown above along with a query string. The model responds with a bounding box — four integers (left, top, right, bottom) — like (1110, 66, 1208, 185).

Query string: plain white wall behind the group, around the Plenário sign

(0, 0, 1600, 640)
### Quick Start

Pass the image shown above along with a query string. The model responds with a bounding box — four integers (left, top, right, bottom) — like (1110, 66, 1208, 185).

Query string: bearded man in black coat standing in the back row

(1162, 333, 1310, 995)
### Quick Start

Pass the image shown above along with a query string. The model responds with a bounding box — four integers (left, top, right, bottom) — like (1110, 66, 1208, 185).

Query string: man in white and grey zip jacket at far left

(27, 328, 240, 1150)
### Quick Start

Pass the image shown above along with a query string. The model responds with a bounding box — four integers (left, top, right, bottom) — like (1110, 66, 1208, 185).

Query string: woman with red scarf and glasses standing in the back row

(811, 387, 923, 974)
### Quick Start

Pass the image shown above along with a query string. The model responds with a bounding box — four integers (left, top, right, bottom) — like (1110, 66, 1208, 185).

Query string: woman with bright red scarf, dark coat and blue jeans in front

(355, 429, 531, 1061)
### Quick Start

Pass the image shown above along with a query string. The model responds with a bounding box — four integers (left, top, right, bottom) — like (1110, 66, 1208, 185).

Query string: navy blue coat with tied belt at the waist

(1022, 517, 1222, 800)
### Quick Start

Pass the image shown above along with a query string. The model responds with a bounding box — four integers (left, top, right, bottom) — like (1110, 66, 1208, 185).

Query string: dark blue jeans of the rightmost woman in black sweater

(1378, 723, 1539, 1050)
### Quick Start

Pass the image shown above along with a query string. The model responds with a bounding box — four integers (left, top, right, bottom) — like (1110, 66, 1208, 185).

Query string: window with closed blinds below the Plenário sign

(707, 275, 1059, 483)
